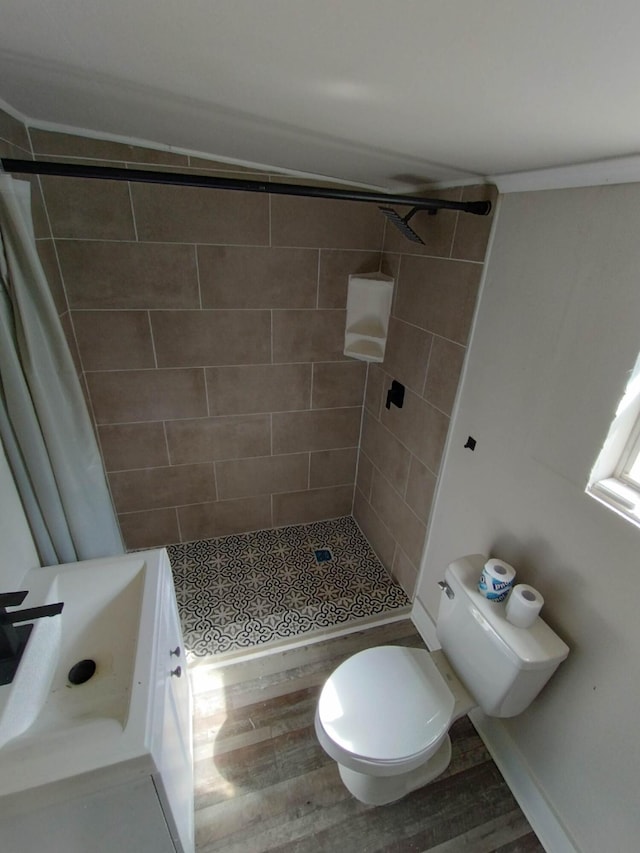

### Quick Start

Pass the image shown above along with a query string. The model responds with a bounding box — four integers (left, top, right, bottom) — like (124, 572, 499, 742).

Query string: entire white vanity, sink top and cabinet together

(0, 549, 194, 853)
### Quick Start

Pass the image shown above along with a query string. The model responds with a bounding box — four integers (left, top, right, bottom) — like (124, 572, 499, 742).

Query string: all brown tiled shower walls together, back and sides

(0, 112, 495, 572)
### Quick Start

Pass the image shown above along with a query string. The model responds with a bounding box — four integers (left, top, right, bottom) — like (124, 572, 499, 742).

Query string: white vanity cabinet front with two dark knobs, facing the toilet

(156, 588, 194, 853)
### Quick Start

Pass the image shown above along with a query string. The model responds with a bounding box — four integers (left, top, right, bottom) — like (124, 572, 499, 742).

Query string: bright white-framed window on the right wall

(586, 356, 640, 527)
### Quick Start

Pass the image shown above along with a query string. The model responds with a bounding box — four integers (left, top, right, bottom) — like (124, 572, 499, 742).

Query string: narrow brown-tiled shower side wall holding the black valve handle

(354, 187, 496, 596)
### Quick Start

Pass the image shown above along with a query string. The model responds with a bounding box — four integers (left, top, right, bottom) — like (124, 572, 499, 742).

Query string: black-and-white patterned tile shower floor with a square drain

(167, 516, 409, 662)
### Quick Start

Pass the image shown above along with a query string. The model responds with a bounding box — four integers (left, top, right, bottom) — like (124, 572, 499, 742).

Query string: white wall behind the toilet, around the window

(418, 184, 640, 853)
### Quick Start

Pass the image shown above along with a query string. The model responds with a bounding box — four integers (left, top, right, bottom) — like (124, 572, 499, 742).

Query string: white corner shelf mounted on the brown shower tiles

(344, 273, 394, 362)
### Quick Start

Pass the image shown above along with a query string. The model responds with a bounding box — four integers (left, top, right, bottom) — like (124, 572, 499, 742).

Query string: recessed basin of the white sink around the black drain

(0, 562, 146, 746)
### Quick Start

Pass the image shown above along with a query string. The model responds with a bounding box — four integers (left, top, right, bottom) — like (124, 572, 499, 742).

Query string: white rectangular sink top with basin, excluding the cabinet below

(0, 551, 170, 796)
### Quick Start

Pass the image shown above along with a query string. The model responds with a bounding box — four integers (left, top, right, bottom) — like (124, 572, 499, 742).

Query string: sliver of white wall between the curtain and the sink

(0, 442, 40, 592)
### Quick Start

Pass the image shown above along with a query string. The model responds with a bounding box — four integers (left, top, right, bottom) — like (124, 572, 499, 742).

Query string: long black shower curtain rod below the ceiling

(0, 157, 491, 216)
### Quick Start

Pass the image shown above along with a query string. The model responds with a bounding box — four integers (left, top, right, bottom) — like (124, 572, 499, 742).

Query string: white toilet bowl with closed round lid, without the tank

(315, 646, 474, 805)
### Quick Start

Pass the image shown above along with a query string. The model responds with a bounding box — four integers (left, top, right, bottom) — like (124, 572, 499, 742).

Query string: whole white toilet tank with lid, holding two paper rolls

(436, 554, 569, 717)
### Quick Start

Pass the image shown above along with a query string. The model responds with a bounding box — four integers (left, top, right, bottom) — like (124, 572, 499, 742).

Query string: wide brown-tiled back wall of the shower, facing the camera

(25, 129, 384, 548)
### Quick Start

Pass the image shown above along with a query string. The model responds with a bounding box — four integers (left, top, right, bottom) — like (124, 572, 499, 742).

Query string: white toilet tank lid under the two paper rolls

(445, 554, 569, 669)
